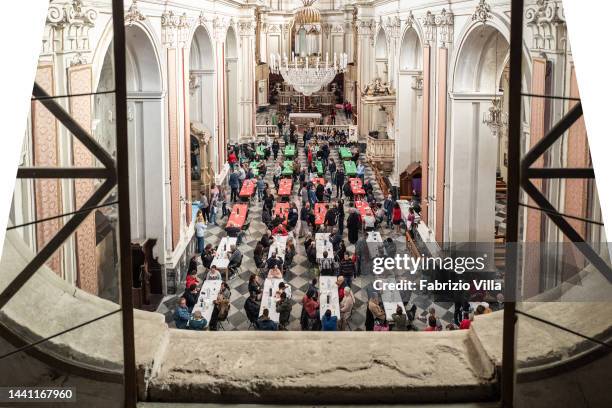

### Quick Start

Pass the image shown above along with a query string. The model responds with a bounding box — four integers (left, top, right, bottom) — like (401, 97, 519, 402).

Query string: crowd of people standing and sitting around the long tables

(175, 108, 490, 331)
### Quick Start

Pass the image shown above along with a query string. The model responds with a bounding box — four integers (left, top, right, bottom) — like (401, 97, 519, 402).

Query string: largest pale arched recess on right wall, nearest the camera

(448, 25, 509, 242)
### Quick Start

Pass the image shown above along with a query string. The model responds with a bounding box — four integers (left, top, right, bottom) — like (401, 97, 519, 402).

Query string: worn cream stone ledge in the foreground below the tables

(147, 329, 496, 403)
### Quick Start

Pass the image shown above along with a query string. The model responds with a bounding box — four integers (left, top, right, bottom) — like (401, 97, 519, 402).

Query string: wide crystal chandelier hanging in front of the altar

(270, 53, 348, 96)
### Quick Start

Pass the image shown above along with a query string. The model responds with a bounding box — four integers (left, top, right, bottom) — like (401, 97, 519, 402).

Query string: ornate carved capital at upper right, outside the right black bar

(525, 0, 567, 52)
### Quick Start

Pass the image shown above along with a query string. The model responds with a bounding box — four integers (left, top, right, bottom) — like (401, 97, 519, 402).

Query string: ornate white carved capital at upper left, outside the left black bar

(43, 0, 98, 53)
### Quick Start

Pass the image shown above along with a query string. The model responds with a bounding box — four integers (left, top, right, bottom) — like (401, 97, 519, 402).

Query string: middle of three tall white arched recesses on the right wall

(396, 27, 423, 194)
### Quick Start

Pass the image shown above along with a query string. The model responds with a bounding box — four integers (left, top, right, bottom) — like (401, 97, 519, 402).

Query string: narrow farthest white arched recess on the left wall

(225, 26, 240, 143)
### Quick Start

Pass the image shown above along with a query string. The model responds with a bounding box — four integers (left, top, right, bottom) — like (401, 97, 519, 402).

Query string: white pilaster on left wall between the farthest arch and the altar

(238, 20, 256, 140)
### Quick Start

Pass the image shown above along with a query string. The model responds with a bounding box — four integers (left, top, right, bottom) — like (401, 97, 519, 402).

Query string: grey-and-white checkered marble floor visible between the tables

(163, 118, 454, 330)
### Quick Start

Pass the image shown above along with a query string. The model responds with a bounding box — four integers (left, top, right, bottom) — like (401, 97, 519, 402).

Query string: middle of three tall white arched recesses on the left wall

(189, 26, 219, 186)
